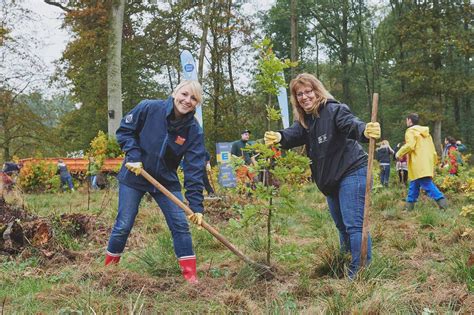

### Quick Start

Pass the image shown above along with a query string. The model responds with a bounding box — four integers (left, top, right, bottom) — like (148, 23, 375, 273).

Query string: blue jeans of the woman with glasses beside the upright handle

(326, 167, 372, 278)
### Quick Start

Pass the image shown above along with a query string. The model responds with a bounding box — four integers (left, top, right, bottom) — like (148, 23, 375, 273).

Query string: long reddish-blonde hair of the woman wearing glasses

(290, 73, 334, 128)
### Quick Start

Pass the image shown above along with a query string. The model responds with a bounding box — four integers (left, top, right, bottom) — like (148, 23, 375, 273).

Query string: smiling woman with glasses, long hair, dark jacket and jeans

(265, 73, 380, 278)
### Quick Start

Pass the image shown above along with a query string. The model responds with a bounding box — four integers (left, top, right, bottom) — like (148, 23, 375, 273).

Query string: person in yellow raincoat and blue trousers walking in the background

(395, 113, 447, 211)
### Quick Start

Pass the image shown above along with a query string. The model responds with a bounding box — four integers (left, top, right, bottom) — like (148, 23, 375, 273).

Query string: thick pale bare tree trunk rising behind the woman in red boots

(107, 0, 125, 136)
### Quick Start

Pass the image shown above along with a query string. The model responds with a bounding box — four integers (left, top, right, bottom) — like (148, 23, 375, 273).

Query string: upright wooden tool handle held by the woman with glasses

(360, 93, 379, 267)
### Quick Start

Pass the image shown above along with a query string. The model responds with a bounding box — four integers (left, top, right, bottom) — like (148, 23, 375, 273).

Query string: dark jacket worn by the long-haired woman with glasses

(279, 100, 369, 196)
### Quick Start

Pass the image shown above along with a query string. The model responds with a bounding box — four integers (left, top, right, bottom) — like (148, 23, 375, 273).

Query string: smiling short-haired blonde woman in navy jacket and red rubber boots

(105, 81, 206, 283)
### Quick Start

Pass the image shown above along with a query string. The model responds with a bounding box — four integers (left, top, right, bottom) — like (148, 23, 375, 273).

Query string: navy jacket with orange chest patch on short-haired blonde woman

(116, 97, 206, 212)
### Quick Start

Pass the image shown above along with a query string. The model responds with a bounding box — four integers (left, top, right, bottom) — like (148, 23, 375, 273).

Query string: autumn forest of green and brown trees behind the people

(0, 0, 474, 161)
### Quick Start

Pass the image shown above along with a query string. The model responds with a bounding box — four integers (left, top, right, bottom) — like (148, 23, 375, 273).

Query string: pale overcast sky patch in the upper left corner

(0, 0, 70, 95)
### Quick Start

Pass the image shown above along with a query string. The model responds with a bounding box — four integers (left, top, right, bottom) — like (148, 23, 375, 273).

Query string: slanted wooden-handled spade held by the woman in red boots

(140, 169, 275, 280)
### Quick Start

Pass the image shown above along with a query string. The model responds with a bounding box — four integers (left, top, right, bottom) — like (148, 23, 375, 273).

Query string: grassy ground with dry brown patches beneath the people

(0, 179, 474, 314)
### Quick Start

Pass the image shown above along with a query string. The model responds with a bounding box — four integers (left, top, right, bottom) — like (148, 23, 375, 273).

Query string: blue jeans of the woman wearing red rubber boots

(107, 184, 194, 258)
